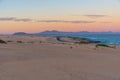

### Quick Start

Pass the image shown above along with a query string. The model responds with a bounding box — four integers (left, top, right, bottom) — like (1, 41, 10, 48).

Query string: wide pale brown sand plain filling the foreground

(0, 36, 120, 80)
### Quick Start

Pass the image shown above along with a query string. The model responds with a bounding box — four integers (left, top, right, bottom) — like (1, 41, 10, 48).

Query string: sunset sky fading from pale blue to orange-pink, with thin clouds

(0, 0, 120, 34)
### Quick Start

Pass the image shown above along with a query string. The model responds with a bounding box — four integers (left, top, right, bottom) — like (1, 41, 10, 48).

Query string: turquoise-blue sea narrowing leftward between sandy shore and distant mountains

(39, 33, 120, 44)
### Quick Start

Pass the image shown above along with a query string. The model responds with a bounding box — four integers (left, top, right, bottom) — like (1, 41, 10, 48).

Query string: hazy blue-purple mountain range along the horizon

(13, 30, 118, 36)
